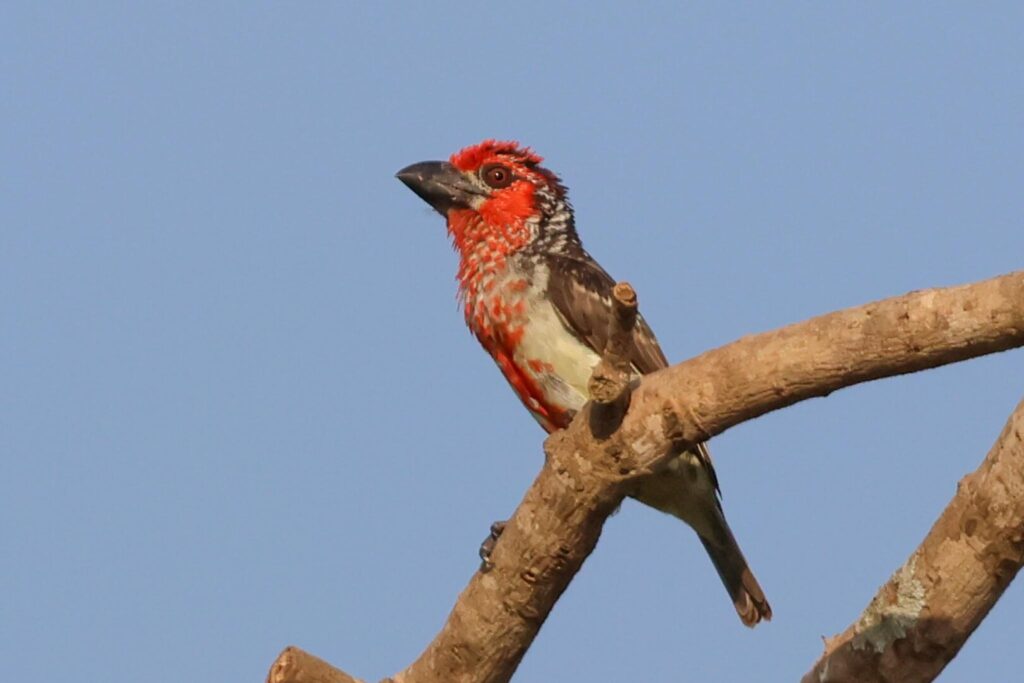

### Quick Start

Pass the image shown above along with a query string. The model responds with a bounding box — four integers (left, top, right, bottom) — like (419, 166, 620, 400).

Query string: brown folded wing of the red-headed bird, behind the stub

(547, 255, 669, 375)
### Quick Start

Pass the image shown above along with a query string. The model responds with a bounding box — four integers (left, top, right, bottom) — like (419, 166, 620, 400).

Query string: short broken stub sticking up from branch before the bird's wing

(588, 283, 637, 439)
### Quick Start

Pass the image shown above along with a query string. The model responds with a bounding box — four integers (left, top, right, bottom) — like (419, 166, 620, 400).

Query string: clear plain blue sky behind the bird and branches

(0, 2, 1024, 683)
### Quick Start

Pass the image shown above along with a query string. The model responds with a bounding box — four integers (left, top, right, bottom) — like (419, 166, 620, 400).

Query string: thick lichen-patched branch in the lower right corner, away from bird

(804, 401, 1024, 683)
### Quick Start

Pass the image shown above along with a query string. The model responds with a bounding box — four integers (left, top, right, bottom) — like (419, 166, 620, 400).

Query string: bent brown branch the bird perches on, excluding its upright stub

(266, 271, 1024, 683)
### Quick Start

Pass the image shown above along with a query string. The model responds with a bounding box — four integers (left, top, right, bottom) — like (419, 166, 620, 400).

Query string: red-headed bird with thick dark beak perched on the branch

(395, 139, 772, 627)
